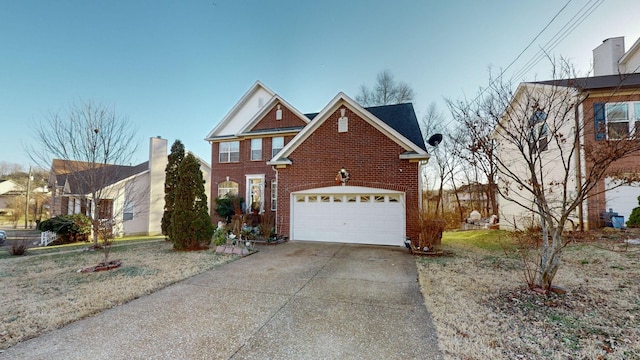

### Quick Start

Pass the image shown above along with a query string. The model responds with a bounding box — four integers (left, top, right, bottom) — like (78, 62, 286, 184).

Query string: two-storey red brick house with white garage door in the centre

(206, 82, 429, 246)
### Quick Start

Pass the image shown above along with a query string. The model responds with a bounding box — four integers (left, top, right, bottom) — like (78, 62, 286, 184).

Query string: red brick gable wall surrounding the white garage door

(277, 108, 418, 243)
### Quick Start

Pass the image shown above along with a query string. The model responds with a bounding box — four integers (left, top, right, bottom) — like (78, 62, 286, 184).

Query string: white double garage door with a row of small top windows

(291, 186, 406, 246)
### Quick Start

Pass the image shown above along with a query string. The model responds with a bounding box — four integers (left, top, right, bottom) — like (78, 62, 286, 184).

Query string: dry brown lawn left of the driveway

(0, 241, 234, 349)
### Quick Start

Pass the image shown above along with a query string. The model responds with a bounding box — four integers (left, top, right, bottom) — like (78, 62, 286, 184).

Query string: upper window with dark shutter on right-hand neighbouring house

(605, 102, 640, 140)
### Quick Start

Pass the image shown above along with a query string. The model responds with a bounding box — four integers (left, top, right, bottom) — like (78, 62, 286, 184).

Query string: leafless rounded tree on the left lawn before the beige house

(26, 101, 143, 249)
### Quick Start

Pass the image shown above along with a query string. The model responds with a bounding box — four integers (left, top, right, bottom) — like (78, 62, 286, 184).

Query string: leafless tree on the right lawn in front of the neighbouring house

(480, 60, 640, 289)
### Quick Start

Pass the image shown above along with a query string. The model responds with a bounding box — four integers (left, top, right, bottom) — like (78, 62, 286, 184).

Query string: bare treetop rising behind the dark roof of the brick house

(356, 70, 414, 106)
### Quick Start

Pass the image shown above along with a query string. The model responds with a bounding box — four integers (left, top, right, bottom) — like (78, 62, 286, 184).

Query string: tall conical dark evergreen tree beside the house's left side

(169, 154, 215, 250)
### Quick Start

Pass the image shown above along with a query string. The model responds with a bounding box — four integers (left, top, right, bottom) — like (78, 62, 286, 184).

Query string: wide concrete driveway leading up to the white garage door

(0, 242, 441, 359)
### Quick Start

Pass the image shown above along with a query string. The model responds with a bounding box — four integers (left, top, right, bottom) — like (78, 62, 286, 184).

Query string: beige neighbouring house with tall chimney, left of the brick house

(49, 137, 211, 236)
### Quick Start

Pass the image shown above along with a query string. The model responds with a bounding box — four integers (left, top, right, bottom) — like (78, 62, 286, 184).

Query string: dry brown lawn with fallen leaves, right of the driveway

(417, 231, 640, 359)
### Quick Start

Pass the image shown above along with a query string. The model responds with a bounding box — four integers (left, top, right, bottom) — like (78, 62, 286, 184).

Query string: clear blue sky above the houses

(0, 0, 640, 167)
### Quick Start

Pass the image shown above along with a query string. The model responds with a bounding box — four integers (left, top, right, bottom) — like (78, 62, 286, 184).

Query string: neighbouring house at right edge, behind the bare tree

(498, 37, 640, 229)
